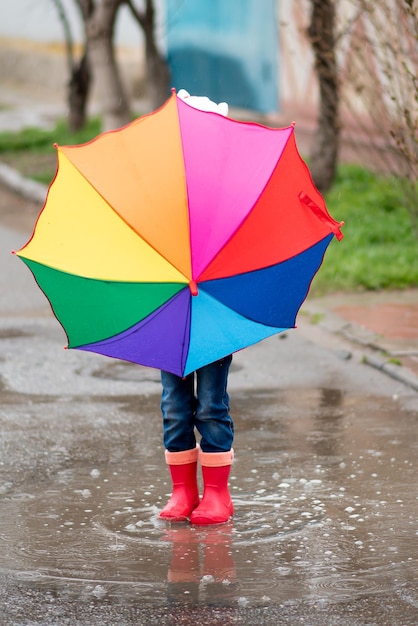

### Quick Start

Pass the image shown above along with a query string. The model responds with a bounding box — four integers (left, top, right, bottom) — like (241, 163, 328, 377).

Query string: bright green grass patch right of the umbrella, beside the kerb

(312, 165, 418, 295)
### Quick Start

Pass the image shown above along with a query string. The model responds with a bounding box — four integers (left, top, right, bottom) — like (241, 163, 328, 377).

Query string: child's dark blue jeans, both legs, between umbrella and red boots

(161, 355, 234, 452)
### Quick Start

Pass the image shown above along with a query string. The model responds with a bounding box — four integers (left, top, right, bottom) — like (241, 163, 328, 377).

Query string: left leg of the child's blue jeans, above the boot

(161, 372, 196, 452)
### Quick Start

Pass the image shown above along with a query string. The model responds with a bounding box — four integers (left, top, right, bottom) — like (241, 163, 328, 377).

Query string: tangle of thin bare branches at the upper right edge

(342, 0, 418, 234)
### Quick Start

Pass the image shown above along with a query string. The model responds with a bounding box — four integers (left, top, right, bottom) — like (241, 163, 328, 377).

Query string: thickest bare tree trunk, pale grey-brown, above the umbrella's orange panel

(77, 0, 130, 131)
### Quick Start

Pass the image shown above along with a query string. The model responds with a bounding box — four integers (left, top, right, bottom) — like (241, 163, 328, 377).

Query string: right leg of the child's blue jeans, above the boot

(195, 356, 234, 452)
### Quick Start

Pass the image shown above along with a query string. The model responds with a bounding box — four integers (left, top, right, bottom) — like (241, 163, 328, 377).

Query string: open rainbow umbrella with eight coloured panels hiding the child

(16, 91, 342, 376)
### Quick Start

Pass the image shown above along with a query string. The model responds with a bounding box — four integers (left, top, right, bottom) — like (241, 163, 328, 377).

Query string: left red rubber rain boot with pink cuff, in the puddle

(159, 446, 199, 522)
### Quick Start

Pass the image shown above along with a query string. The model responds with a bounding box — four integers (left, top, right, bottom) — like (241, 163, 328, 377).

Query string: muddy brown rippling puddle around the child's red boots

(0, 389, 418, 623)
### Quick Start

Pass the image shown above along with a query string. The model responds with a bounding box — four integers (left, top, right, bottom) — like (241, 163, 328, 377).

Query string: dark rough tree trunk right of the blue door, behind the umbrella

(308, 0, 340, 192)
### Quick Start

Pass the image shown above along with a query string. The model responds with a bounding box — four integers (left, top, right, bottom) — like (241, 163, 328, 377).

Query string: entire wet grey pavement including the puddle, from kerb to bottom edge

(0, 179, 418, 626)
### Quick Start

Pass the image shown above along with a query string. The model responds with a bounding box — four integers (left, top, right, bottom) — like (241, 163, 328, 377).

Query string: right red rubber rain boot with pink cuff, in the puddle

(190, 449, 234, 525)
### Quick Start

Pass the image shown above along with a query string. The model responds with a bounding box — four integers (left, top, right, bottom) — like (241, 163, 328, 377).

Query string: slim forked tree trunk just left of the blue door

(126, 0, 170, 109)
